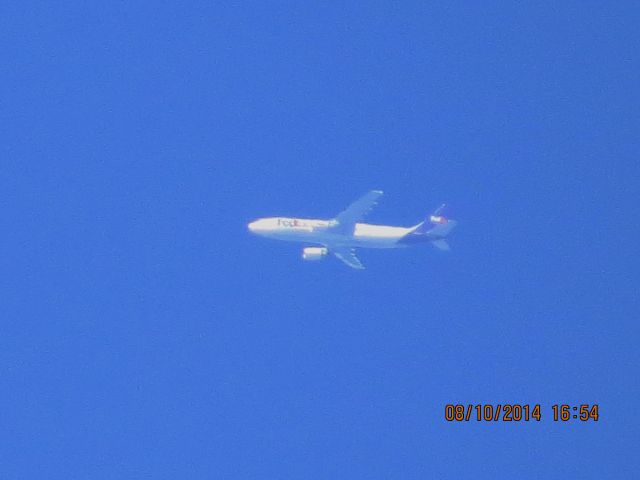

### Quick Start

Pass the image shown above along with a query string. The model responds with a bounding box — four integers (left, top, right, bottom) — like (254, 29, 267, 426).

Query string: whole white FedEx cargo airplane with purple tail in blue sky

(248, 190, 458, 270)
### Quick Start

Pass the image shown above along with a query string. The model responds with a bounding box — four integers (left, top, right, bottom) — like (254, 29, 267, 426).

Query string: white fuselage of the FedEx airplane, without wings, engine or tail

(249, 217, 413, 248)
